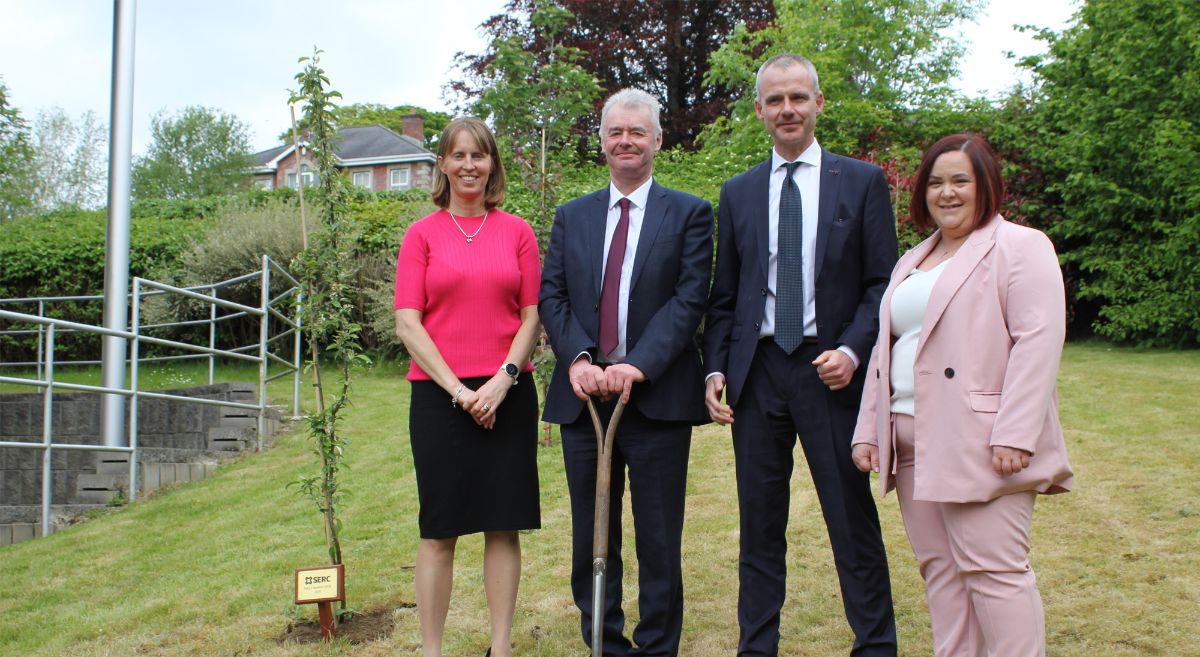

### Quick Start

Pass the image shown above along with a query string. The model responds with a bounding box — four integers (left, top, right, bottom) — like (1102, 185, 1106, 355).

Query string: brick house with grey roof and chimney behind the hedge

(253, 114, 437, 192)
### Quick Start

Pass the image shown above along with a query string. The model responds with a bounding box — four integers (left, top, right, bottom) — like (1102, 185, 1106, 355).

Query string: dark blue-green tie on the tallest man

(775, 162, 804, 354)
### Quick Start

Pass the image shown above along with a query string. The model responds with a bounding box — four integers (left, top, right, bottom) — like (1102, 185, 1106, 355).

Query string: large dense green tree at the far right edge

(1025, 0, 1200, 346)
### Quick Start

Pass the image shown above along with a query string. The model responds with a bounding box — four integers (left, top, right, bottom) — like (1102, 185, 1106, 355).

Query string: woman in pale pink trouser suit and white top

(853, 134, 1072, 657)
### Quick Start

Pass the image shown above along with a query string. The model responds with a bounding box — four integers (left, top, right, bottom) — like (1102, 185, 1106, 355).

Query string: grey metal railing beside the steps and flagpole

(0, 255, 302, 536)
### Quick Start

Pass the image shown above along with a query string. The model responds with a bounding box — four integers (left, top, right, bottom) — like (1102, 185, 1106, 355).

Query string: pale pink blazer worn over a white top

(853, 215, 1072, 502)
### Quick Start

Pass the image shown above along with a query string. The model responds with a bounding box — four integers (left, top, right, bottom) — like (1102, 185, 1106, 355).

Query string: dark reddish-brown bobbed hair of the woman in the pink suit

(908, 132, 1004, 230)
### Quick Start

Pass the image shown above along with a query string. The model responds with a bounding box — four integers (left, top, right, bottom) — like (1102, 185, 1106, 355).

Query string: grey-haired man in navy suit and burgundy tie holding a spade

(538, 89, 710, 657)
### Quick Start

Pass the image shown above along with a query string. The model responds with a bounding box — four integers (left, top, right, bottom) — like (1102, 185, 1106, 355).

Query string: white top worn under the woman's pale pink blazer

(890, 259, 950, 415)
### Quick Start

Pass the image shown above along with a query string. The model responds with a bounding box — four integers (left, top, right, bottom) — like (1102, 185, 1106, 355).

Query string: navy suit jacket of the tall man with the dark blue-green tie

(704, 149, 899, 409)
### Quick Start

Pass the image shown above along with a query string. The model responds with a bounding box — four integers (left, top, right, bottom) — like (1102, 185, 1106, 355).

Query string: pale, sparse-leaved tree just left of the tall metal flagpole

(32, 107, 108, 212)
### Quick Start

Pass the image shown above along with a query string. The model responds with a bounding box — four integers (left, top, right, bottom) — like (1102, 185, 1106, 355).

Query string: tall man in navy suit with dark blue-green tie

(704, 55, 896, 657)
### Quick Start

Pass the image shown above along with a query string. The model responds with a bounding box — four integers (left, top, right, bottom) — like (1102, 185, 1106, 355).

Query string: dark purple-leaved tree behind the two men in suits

(450, 0, 774, 147)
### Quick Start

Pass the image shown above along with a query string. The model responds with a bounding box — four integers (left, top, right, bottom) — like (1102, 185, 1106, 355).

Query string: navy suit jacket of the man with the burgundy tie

(538, 182, 713, 424)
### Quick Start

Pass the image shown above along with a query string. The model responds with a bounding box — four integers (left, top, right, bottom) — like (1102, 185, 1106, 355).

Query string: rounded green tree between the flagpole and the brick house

(133, 106, 253, 199)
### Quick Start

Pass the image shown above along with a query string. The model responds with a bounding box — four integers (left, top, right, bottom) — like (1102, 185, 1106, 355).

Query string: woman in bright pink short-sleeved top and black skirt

(395, 119, 541, 657)
